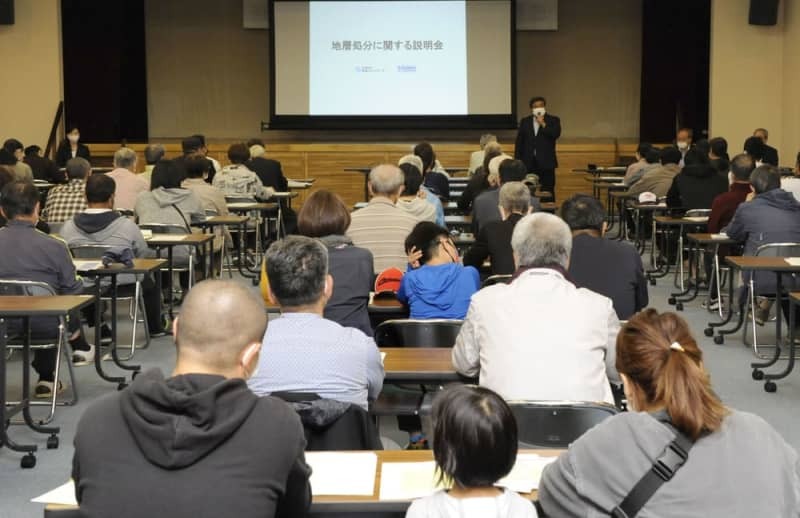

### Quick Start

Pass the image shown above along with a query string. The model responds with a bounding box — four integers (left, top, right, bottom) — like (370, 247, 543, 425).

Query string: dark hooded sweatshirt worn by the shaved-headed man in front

(72, 369, 311, 518)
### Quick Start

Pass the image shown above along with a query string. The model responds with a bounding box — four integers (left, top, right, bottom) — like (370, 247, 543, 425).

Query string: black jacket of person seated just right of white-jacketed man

(569, 234, 649, 320)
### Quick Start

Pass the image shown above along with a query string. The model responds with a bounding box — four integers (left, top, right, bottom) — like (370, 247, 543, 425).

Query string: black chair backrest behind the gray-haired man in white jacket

(509, 401, 618, 448)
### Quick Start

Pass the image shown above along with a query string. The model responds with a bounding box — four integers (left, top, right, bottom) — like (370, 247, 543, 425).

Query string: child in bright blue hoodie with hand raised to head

(397, 221, 481, 320)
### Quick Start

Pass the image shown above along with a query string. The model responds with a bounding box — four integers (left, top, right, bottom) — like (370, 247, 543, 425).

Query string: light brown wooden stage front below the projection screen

(89, 139, 636, 208)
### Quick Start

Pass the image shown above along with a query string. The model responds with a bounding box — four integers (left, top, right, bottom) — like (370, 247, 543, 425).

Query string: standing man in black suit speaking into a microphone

(514, 97, 561, 199)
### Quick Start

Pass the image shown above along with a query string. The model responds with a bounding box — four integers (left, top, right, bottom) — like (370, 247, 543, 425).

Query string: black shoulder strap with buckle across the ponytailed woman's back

(611, 421, 694, 518)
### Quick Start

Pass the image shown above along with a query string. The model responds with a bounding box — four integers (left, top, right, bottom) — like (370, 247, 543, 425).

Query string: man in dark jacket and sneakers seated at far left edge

(0, 181, 94, 398)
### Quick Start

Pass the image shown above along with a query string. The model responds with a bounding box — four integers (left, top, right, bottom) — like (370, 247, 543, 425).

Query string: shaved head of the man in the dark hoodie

(175, 280, 267, 372)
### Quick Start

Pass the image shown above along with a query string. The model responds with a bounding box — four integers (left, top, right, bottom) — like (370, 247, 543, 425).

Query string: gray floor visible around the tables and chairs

(0, 268, 800, 518)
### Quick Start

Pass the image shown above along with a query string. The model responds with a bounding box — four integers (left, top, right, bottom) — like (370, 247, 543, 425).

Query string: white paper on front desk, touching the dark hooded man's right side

(306, 452, 378, 496)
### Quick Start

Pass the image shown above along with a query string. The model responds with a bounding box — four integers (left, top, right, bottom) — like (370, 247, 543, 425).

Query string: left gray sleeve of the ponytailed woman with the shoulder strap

(539, 450, 589, 516)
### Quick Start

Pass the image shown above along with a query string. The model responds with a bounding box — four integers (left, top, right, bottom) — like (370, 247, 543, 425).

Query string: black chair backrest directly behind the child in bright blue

(375, 320, 464, 347)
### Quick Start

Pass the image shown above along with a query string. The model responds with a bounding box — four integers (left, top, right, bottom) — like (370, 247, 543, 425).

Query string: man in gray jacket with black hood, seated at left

(61, 174, 165, 337)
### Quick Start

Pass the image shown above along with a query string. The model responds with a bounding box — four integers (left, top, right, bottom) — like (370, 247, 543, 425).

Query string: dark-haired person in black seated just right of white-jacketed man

(561, 194, 649, 320)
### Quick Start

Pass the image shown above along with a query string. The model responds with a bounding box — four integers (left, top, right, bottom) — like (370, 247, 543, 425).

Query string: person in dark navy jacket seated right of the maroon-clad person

(723, 165, 800, 322)
